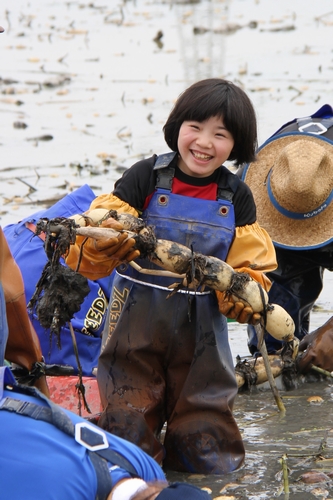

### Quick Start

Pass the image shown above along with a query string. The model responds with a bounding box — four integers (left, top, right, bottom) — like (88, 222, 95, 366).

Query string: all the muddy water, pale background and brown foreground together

(0, 0, 333, 499)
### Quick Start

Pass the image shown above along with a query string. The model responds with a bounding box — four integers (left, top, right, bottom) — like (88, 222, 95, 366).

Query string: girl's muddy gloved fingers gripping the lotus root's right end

(216, 291, 261, 325)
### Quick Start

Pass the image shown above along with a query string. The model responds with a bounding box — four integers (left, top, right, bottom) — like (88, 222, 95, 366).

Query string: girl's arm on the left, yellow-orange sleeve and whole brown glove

(66, 193, 139, 280)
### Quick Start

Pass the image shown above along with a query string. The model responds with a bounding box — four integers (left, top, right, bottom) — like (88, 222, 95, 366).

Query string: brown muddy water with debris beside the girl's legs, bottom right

(168, 381, 333, 500)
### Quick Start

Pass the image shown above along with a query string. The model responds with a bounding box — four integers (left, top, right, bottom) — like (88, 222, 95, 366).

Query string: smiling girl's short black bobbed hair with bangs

(163, 78, 258, 166)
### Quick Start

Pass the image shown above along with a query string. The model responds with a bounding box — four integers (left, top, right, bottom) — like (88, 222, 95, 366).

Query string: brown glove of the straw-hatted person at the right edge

(297, 317, 333, 372)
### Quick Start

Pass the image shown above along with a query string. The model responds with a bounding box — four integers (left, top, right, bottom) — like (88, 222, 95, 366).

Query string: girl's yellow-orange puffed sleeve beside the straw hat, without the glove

(226, 222, 277, 292)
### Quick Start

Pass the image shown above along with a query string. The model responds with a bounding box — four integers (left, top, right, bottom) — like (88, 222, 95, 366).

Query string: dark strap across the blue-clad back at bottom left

(0, 385, 138, 500)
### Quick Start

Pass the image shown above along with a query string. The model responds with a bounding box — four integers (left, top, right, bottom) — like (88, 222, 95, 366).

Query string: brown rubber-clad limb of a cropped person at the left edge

(0, 227, 49, 396)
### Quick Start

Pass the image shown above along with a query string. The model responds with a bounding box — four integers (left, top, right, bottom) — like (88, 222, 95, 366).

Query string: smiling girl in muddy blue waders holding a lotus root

(67, 78, 276, 474)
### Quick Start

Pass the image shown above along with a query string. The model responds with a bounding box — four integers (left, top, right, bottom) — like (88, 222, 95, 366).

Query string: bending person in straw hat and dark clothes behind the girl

(241, 104, 333, 370)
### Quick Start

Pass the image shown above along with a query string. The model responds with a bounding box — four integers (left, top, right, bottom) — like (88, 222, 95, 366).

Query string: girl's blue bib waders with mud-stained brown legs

(97, 153, 244, 474)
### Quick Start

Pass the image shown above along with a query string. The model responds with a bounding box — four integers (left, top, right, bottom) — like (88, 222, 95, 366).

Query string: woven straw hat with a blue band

(243, 124, 333, 250)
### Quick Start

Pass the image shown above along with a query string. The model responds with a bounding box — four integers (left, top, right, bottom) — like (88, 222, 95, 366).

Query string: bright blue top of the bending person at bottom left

(0, 367, 165, 500)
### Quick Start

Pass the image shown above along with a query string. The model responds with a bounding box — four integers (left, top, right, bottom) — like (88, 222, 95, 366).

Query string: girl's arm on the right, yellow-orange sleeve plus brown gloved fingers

(216, 222, 277, 324)
